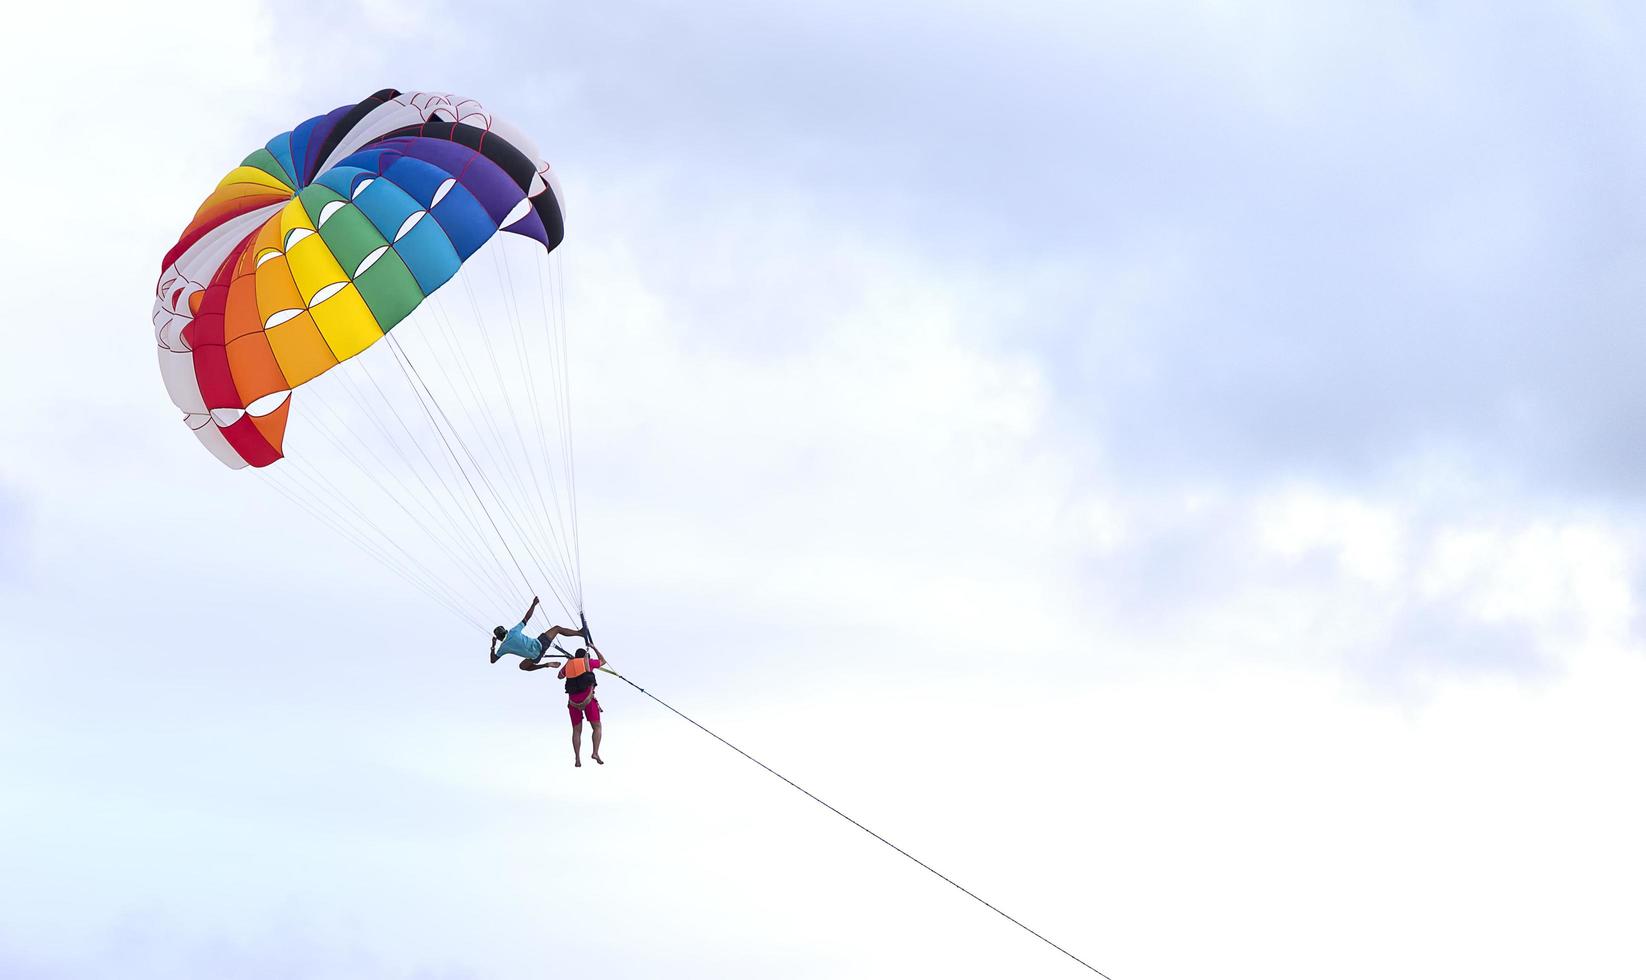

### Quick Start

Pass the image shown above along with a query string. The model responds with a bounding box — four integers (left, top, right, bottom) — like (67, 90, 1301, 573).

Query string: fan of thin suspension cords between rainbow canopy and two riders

(256, 236, 583, 626)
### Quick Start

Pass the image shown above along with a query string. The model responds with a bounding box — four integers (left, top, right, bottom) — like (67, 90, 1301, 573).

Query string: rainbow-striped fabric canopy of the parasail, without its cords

(155, 89, 565, 468)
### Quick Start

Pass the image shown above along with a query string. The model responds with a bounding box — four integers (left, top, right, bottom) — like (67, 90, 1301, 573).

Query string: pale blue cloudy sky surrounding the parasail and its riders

(0, 0, 1646, 980)
